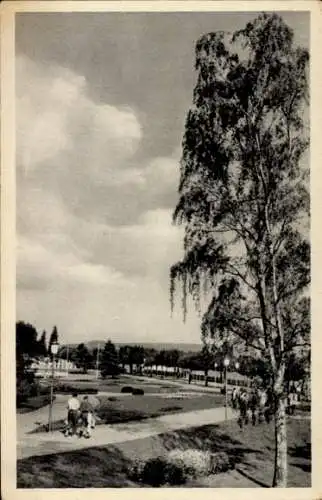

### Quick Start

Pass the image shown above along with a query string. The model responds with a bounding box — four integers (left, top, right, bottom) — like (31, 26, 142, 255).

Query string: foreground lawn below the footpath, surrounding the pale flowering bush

(17, 419, 311, 488)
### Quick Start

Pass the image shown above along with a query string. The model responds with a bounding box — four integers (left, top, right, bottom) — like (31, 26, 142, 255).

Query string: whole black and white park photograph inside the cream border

(0, 2, 312, 494)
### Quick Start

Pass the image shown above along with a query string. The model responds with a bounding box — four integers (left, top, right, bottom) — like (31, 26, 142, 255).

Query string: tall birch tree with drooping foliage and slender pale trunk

(170, 14, 310, 484)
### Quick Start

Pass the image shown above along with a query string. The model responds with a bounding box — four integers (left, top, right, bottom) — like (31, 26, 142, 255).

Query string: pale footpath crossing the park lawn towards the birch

(17, 407, 236, 459)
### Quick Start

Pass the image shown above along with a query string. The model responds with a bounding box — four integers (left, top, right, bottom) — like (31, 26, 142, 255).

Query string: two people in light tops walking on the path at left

(64, 393, 95, 439)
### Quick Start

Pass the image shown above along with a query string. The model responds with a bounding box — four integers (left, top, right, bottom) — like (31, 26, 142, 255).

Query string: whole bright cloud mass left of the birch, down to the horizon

(17, 57, 199, 341)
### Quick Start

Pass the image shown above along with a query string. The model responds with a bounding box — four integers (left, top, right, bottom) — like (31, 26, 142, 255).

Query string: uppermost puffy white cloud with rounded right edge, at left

(16, 56, 142, 176)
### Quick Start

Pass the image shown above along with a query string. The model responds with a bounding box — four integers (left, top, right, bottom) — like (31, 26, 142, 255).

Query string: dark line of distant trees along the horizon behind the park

(16, 321, 308, 395)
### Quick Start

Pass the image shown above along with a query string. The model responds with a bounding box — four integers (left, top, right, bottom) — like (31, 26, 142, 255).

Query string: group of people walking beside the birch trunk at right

(231, 387, 298, 428)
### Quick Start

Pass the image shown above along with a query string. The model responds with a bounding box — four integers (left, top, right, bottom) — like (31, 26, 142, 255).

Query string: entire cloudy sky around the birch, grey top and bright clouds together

(16, 13, 309, 342)
